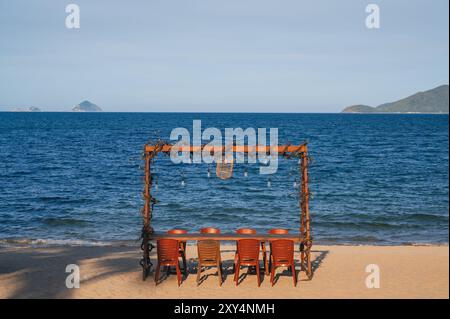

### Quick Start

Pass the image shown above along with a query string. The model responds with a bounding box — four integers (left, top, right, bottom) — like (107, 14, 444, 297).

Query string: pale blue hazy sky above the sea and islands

(0, 0, 449, 112)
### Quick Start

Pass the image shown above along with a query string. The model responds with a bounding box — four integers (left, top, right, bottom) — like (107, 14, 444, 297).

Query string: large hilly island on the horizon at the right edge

(342, 85, 449, 114)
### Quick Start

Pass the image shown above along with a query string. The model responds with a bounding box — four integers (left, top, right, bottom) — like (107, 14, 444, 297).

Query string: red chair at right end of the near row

(270, 239, 297, 286)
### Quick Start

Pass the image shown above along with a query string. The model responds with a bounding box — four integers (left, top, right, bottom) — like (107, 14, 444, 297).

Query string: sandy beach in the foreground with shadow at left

(0, 244, 449, 298)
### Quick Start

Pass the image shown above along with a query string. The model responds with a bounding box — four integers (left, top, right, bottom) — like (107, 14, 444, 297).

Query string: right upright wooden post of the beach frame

(300, 145, 312, 279)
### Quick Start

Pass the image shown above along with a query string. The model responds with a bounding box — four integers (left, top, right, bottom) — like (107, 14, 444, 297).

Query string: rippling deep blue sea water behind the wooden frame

(0, 113, 449, 245)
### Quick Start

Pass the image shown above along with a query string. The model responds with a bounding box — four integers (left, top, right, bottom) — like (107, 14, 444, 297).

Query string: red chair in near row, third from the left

(234, 239, 261, 287)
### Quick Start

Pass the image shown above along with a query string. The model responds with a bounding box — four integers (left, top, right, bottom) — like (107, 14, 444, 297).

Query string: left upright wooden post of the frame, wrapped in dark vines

(142, 151, 152, 280)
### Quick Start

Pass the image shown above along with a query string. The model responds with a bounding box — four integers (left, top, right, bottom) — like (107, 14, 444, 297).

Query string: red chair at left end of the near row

(155, 239, 181, 286)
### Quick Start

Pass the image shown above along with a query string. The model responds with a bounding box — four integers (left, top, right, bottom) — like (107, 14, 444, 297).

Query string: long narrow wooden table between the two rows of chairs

(152, 232, 303, 276)
